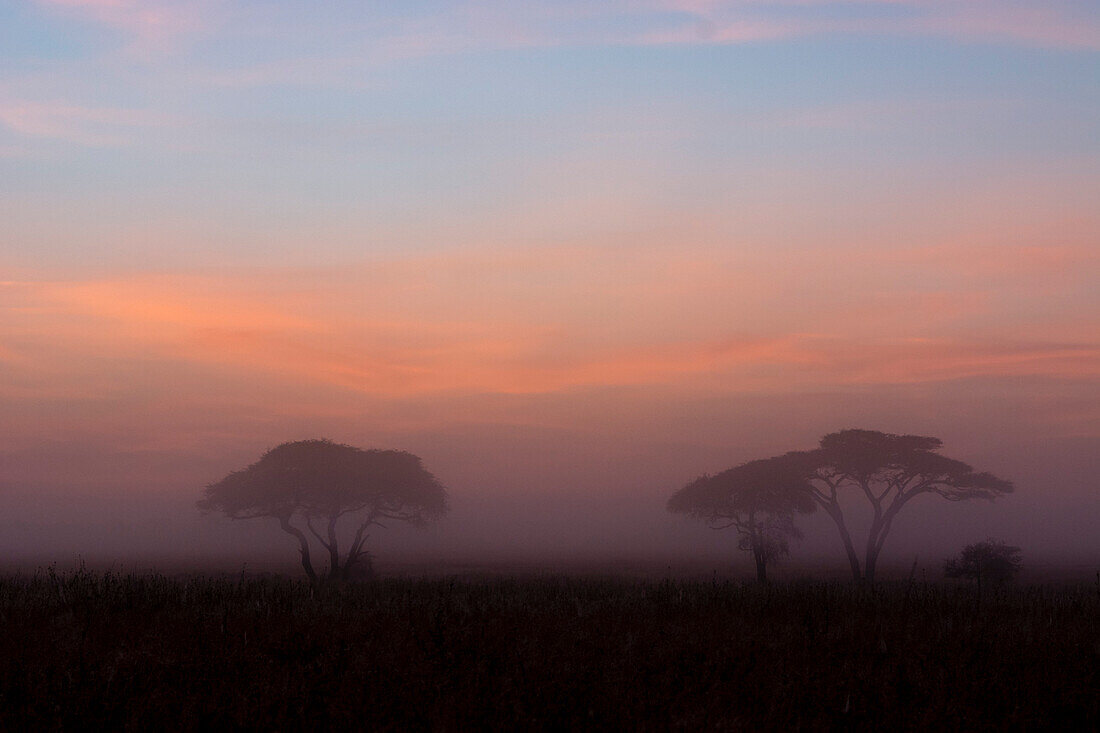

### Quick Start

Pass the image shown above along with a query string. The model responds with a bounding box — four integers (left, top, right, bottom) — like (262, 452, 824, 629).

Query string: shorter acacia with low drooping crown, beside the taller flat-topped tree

(668, 457, 815, 583)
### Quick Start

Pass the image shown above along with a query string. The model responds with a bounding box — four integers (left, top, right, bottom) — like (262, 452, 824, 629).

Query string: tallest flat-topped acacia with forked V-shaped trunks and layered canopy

(788, 429, 1013, 581)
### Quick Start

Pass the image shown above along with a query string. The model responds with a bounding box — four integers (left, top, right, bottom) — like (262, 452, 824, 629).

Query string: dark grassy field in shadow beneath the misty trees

(0, 571, 1100, 730)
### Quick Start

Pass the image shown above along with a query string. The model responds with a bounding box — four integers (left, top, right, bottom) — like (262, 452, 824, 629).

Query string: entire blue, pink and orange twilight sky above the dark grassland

(0, 0, 1100, 567)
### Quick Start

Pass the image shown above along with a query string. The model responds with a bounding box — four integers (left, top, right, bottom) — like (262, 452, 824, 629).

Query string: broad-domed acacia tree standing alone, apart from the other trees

(198, 440, 448, 581)
